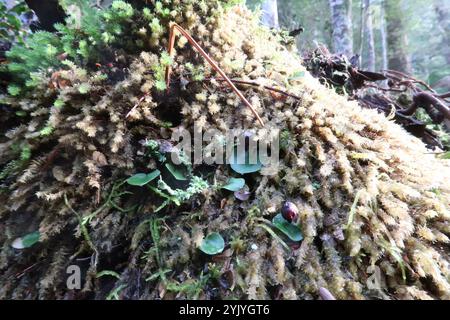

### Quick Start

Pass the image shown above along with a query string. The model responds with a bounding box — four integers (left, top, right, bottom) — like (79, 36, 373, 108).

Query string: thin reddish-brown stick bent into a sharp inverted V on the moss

(166, 22, 264, 126)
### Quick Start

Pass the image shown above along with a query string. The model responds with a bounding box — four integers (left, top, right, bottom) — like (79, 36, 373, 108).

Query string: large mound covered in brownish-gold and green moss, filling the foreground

(0, 0, 450, 299)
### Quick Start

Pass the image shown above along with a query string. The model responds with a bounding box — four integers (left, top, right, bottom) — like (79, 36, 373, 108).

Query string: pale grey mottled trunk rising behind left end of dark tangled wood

(328, 0, 353, 57)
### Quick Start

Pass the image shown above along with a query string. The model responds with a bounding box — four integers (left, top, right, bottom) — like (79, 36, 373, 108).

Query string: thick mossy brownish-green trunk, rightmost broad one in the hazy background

(384, 0, 412, 73)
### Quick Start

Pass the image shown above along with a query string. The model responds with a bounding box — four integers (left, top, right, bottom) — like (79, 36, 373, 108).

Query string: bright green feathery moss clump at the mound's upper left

(7, 1, 135, 96)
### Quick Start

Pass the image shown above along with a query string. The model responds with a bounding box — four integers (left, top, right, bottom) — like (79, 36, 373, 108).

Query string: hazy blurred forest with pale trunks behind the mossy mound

(247, 0, 450, 92)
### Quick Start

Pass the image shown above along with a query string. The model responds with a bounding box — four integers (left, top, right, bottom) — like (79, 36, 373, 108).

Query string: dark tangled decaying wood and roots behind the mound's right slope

(305, 46, 450, 148)
